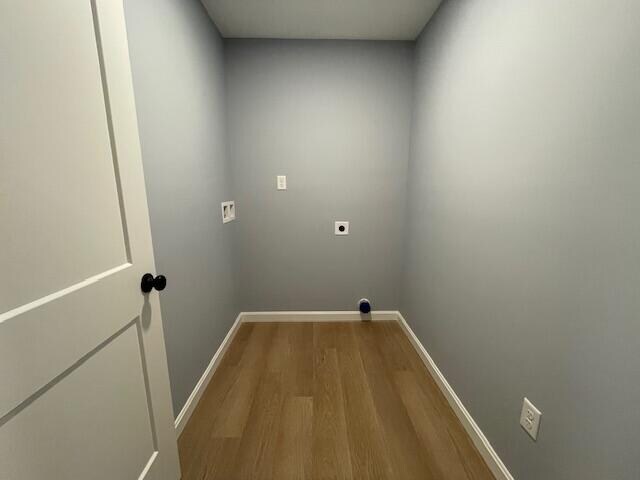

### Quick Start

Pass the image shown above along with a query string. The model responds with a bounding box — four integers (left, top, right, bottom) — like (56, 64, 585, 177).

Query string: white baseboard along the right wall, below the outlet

(397, 312, 514, 480)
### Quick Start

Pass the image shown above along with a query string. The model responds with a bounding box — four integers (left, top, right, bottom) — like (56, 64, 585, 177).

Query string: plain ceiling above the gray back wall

(202, 0, 441, 40)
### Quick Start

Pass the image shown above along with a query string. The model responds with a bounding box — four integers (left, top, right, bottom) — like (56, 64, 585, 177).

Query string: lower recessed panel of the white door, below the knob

(0, 322, 155, 480)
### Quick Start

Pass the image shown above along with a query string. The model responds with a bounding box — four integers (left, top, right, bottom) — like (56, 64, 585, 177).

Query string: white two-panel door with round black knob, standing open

(0, 0, 180, 480)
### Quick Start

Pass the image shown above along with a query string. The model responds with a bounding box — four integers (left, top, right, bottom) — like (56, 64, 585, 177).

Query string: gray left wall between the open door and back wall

(124, 0, 239, 414)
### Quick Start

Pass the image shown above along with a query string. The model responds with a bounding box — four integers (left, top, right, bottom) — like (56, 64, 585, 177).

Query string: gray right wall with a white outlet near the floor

(401, 0, 640, 480)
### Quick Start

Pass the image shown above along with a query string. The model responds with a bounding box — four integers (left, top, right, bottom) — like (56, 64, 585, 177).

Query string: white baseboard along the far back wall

(242, 310, 398, 322)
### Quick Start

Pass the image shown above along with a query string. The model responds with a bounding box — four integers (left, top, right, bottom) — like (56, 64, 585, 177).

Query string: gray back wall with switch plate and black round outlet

(225, 40, 413, 310)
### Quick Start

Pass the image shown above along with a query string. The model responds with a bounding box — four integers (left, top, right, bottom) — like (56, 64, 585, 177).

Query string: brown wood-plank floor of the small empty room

(179, 322, 493, 480)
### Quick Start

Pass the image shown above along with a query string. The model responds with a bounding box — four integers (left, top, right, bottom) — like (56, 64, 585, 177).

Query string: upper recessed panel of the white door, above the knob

(0, 1, 128, 313)
